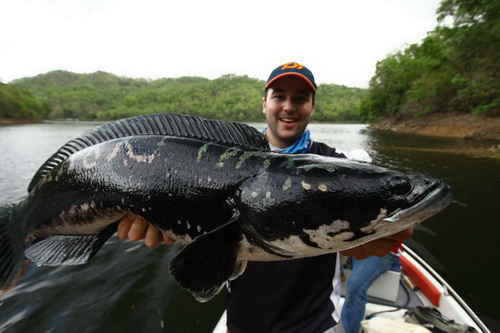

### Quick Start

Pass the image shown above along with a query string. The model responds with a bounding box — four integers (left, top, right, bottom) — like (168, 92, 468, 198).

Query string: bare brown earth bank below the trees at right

(369, 113, 500, 158)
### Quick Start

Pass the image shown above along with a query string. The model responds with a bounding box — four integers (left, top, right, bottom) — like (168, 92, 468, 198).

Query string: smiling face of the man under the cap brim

(262, 75, 314, 148)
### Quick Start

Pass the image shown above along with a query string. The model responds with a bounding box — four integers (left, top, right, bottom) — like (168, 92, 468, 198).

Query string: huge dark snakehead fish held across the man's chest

(0, 114, 451, 300)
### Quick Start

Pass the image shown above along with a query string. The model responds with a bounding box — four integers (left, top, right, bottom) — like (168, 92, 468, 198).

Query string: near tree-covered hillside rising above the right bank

(361, 0, 500, 121)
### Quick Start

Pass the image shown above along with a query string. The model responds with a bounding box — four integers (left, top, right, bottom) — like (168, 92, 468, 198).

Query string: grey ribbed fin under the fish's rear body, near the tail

(24, 223, 118, 266)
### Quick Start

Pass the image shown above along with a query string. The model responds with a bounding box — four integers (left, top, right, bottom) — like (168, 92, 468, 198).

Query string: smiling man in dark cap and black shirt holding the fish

(118, 63, 413, 333)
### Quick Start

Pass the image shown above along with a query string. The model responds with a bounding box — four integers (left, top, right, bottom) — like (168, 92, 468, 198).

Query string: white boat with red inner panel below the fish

(213, 245, 490, 333)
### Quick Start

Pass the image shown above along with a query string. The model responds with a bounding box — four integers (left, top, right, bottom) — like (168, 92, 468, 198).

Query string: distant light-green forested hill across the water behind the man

(6, 71, 366, 122)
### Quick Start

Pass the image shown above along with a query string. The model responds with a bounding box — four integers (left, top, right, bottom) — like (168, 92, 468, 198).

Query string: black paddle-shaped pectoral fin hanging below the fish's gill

(170, 213, 244, 302)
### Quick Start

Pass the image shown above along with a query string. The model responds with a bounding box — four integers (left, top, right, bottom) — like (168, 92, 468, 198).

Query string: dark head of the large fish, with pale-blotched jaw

(239, 155, 452, 258)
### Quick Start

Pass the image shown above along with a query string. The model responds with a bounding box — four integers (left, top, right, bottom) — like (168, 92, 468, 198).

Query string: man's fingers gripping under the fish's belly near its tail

(116, 214, 175, 247)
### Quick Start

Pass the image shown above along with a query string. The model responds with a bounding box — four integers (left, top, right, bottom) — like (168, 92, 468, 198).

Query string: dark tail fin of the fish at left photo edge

(0, 205, 28, 294)
